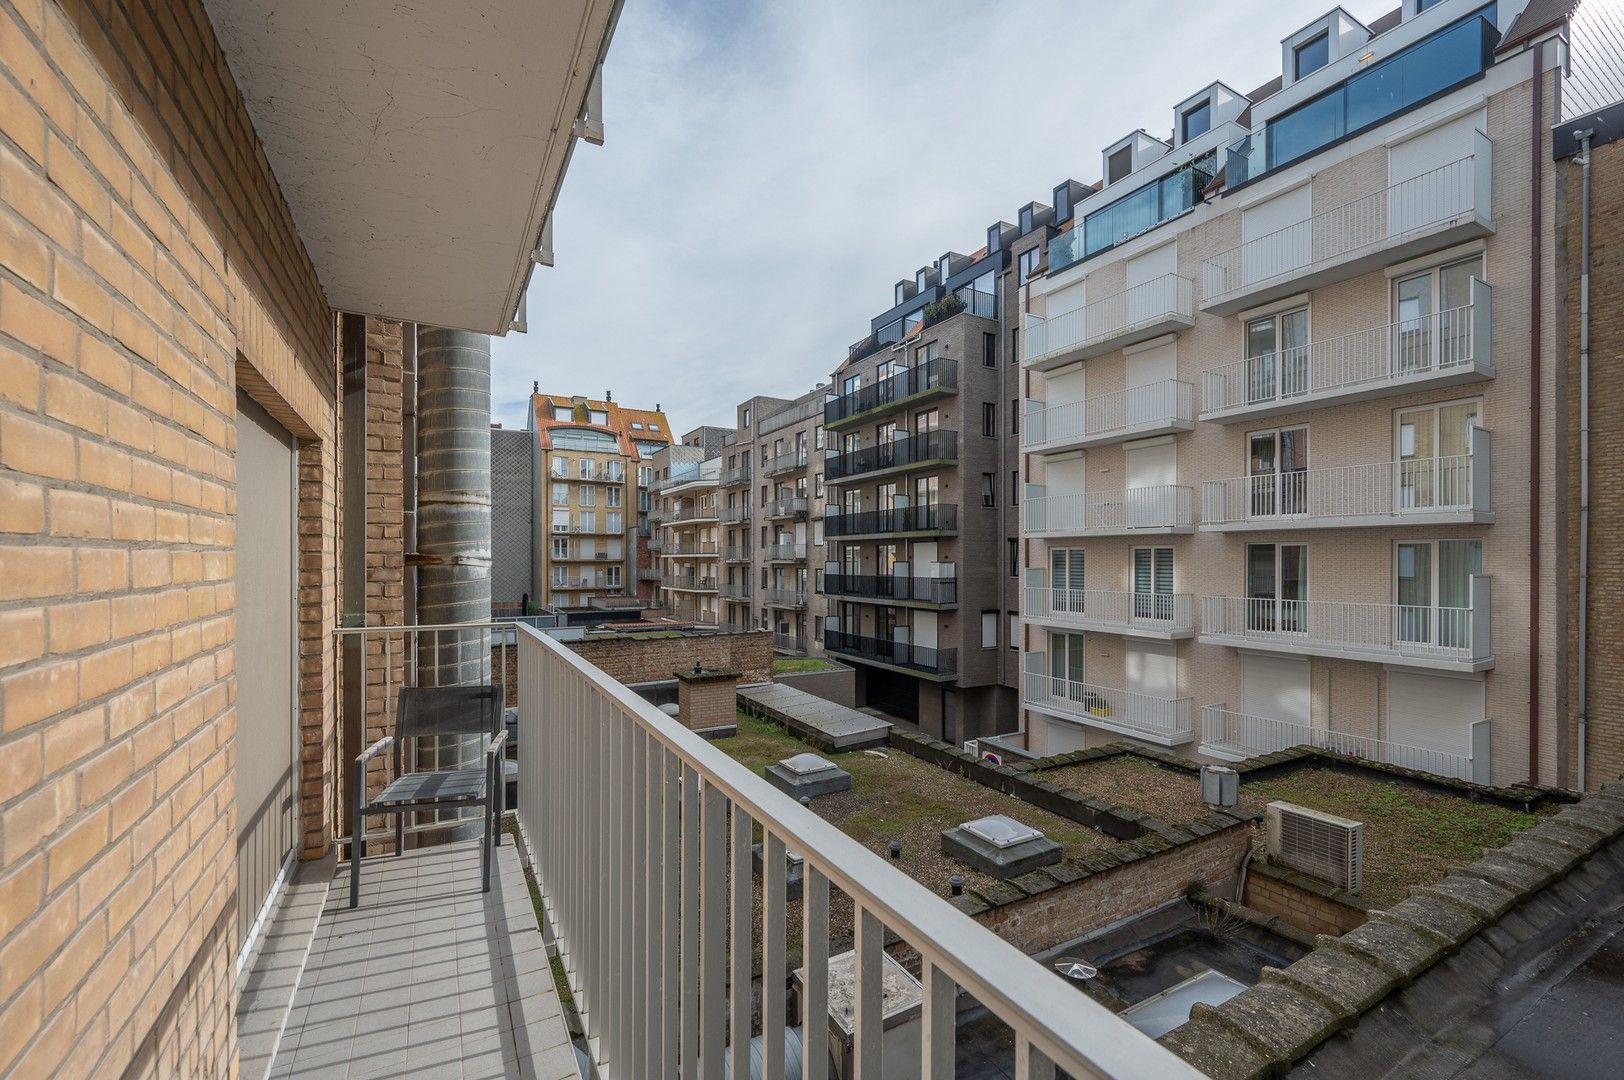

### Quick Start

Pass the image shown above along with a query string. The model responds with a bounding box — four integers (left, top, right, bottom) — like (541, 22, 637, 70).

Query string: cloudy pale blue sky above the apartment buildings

(492, 0, 1377, 434)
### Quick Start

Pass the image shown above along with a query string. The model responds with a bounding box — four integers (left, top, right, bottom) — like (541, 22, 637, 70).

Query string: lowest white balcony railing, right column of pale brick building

(1200, 705, 1492, 784)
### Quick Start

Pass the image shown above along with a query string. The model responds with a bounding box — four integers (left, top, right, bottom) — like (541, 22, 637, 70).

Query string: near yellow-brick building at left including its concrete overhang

(0, 0, 614, 1077)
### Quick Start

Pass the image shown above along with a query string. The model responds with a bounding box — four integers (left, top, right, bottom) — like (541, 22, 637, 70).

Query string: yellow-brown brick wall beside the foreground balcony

(0, 0, 336, 1077)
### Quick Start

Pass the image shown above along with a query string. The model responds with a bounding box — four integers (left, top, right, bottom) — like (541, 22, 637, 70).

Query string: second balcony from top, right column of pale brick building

(1202, 278, 1494, 424)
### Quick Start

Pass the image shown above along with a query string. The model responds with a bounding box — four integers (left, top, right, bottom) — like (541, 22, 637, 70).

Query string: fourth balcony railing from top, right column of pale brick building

(1200, 573, 1494, 671)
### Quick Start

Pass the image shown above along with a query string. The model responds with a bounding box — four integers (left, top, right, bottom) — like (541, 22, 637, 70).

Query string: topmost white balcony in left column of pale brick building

(1021, 274, 1195, 372)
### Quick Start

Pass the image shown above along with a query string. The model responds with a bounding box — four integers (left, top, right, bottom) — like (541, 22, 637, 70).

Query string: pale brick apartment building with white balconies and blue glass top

(1020, 0, 1566, 783)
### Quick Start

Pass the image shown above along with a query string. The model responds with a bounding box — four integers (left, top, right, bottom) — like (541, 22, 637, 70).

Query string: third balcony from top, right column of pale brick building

(1202, 427, 1494, 533)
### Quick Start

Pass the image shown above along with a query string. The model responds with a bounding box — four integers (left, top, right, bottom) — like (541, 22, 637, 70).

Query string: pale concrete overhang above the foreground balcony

(205, 0, 619, 333)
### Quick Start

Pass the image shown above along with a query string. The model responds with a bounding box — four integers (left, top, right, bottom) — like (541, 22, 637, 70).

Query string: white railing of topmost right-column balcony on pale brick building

(1202, 142, 1492, 305)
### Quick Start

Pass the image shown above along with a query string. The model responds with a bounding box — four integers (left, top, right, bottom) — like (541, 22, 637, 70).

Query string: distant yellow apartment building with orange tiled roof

(528, 391, 672, 607)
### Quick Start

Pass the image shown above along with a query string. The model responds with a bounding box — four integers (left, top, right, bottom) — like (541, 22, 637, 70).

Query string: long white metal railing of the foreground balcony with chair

(518, 629, 1200, 1080)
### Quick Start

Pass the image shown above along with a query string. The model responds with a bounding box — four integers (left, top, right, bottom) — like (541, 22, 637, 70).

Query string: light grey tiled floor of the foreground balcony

(259, 836, 578, 1080)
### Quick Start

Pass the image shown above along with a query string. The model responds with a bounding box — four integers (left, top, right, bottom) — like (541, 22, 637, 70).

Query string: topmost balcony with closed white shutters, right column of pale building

(1202, 142, 1494, 315)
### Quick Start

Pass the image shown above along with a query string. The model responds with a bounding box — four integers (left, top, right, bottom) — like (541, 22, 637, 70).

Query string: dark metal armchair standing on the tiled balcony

(349, 687, 507, 908)
